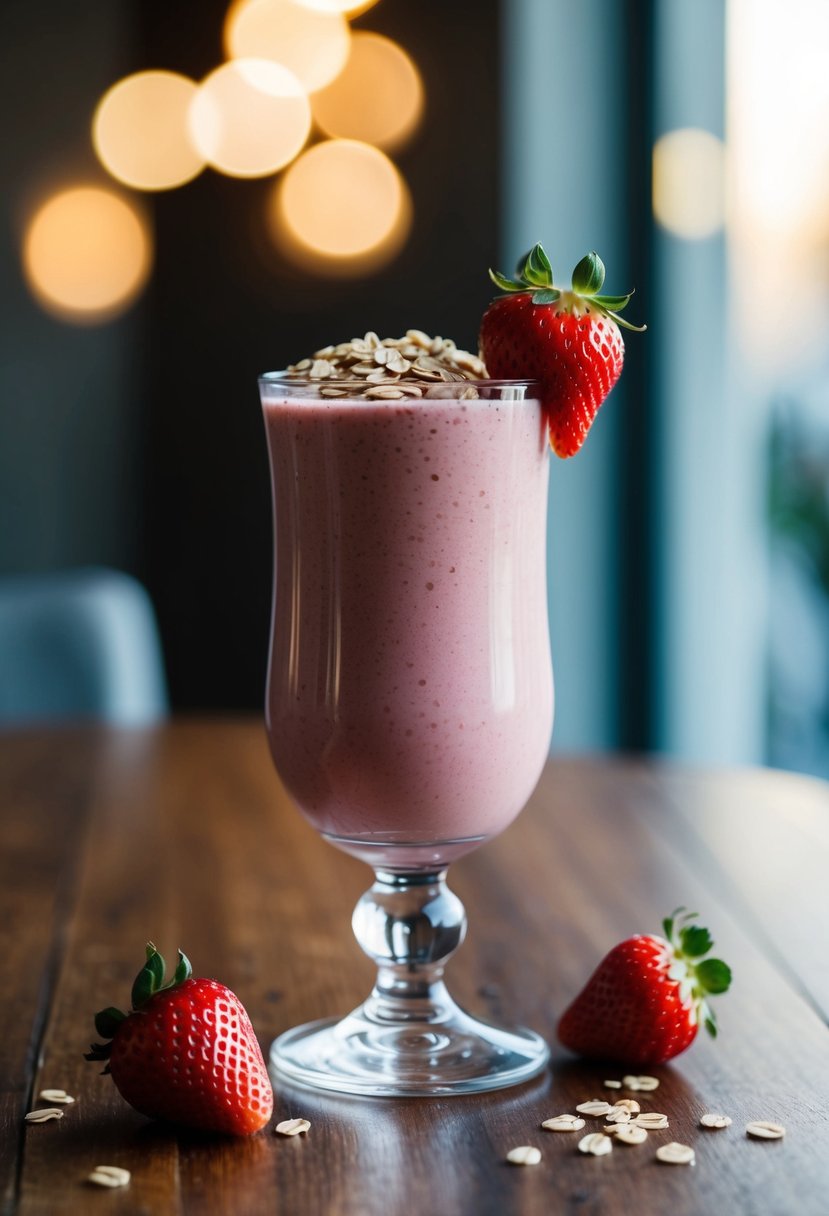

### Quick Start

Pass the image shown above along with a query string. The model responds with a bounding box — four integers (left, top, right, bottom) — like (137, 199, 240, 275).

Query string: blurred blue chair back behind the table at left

(0, 569, 169, 726)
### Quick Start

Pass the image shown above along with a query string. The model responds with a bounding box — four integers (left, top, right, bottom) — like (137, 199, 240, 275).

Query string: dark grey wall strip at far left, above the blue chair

(0, 0, 143, 574)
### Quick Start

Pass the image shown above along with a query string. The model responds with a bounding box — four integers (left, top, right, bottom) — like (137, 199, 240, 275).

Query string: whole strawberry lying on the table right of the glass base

(558, 908, 732, 1066)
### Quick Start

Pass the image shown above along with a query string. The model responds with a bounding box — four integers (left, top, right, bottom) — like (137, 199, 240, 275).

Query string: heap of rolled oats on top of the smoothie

(288, 330, 486, 400)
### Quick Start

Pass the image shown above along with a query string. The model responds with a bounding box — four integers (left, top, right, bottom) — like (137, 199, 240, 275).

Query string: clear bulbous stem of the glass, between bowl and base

(351, 869, 467, 1025)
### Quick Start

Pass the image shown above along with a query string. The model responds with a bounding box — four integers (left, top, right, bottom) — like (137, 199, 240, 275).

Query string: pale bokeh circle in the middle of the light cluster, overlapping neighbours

(190, 60, 311, 178)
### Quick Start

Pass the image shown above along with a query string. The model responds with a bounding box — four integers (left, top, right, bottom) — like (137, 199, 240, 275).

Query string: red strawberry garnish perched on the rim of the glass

(479, 244, 645, 456)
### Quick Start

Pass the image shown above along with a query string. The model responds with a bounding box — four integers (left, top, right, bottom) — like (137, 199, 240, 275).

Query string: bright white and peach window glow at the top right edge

(727, 0, 829, 376)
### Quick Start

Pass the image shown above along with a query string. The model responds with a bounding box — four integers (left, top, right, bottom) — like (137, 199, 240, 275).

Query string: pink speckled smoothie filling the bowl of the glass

(264, 388, 553, 868)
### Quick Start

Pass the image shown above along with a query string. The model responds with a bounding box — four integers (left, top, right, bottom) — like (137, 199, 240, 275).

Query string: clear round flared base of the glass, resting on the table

(270, 1002, 549, 1098)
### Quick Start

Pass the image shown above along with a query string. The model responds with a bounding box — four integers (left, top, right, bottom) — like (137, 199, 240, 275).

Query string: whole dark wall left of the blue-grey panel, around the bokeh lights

(0, 0, 501, 710)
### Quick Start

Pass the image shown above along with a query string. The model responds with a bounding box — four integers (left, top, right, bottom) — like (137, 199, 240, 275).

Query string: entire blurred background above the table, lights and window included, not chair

(0, 0, 829, 776)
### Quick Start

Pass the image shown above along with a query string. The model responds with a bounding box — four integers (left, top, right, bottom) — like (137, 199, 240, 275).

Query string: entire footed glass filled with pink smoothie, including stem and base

(260, 373, 553, 1094)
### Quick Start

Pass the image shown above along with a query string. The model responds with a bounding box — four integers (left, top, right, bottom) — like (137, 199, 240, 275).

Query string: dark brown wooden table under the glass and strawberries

(0, 722, 829, 1216)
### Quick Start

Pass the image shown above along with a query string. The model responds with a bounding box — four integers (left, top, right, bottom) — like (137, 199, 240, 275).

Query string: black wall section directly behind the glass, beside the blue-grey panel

(137, 0, 500, 709)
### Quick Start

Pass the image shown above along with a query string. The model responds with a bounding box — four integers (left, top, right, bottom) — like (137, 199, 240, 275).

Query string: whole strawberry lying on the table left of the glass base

(85, 942, 273, 1136)
